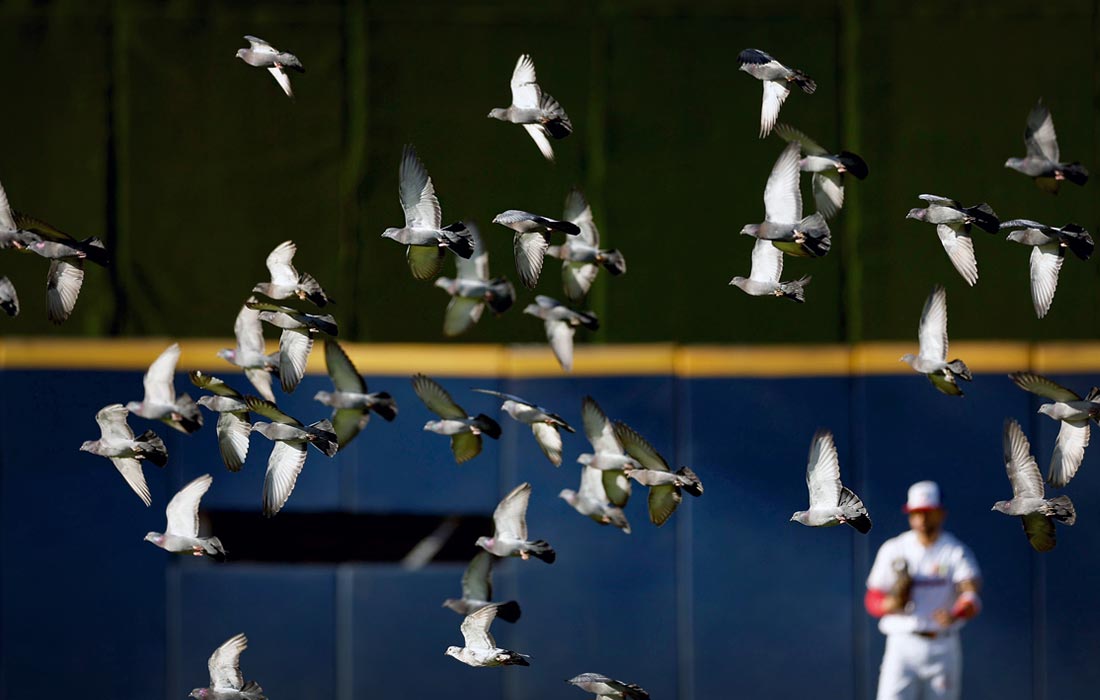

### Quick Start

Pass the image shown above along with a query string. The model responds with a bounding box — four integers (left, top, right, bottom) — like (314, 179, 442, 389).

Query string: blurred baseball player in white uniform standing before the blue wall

(864, 481, 981, 700)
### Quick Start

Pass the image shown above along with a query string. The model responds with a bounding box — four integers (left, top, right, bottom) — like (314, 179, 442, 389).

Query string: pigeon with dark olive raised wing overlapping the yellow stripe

(314, 338, 397, 450)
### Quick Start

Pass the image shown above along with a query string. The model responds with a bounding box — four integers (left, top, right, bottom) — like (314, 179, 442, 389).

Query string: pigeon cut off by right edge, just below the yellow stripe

(1009, 372, 1100, 489)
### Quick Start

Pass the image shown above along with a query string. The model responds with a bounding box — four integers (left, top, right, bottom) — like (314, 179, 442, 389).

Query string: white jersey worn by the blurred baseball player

(867, 531, 981, 635)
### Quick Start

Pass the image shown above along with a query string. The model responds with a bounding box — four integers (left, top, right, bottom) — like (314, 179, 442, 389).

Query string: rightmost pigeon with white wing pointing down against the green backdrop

(1000, 219, 1095, 318)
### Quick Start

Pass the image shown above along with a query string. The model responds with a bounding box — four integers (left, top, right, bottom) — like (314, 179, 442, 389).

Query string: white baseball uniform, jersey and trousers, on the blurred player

(867, 531, 981, 700)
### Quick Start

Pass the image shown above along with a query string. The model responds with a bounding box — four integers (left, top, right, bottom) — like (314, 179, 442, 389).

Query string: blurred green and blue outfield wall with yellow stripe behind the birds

(0, 0, 1100, 700)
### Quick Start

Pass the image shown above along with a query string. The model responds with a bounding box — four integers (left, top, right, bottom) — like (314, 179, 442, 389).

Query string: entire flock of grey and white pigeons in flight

(0, 36, 1100, 700)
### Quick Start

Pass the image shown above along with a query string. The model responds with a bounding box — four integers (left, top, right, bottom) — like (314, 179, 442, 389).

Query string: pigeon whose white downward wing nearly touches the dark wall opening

(244, 396, 340, 517)
